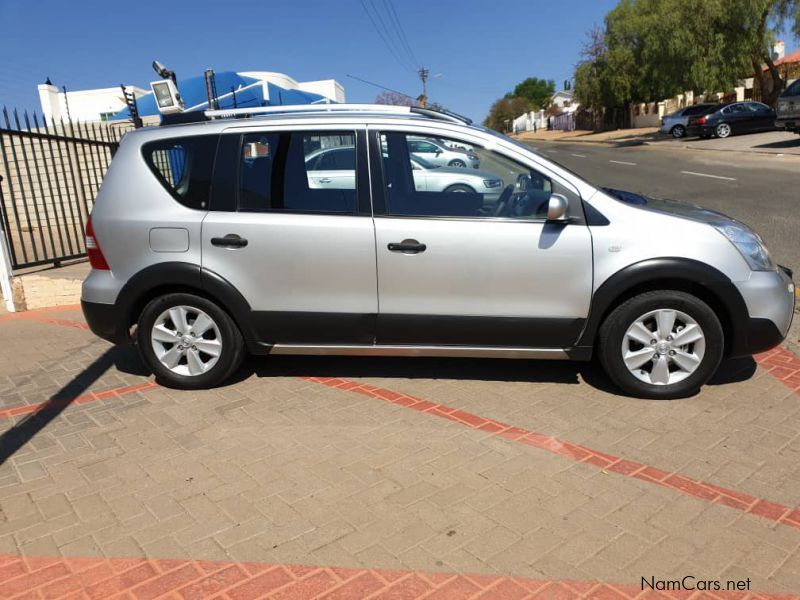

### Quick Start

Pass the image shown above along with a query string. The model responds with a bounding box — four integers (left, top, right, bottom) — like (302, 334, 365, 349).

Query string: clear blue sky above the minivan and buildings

(0, 0, 796, 119)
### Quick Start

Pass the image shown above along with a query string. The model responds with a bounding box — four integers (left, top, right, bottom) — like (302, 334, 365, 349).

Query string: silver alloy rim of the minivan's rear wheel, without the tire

(150, 306, 222, 377)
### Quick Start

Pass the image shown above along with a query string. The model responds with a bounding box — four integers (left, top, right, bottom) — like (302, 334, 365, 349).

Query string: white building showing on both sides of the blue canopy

(39, 71, 345, 121)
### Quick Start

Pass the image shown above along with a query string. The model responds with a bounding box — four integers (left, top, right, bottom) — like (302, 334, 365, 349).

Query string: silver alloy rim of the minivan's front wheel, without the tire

(622, 308, 706, 385)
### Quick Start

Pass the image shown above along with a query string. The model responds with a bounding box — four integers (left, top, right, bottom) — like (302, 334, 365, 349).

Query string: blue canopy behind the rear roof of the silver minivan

(110, 71, 326, 121)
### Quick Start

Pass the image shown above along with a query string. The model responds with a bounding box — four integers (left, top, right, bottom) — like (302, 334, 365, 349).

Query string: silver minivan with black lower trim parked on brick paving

(82, 105, 795, 398)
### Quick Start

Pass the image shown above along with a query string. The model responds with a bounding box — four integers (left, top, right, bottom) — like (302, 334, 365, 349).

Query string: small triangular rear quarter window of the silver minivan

(142, 135, 218, 209)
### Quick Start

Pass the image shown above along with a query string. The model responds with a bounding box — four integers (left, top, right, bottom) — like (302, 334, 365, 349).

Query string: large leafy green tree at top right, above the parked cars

(575, 0, 800, 107)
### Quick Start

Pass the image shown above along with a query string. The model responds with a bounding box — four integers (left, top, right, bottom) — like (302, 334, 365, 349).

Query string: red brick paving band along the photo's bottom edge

(0, 555, 800, 600)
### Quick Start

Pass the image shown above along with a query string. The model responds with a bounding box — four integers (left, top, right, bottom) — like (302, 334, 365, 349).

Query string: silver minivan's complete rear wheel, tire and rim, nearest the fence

(137, 293, 244, 389)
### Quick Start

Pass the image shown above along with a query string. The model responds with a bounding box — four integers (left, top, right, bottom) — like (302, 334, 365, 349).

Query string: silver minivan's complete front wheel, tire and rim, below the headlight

(599, 290, 724, 400)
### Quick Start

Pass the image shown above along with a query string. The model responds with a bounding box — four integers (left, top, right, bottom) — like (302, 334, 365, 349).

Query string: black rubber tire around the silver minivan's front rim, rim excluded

(598, 290, 725, 400)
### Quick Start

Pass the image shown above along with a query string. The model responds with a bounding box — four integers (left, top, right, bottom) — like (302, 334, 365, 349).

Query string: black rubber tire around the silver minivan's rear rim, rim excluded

(136, 293, 245, 390)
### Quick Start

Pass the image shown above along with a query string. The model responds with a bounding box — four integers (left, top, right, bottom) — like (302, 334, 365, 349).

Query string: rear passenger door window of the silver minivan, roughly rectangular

(239, 132, 356, 214)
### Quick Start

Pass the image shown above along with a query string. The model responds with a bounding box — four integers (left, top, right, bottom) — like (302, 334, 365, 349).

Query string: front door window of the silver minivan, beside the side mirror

(381, 133, 561, 219)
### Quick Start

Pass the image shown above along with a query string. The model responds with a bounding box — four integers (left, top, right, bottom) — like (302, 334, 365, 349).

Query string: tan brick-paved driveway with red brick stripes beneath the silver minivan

(0, 307, 800, 599)
